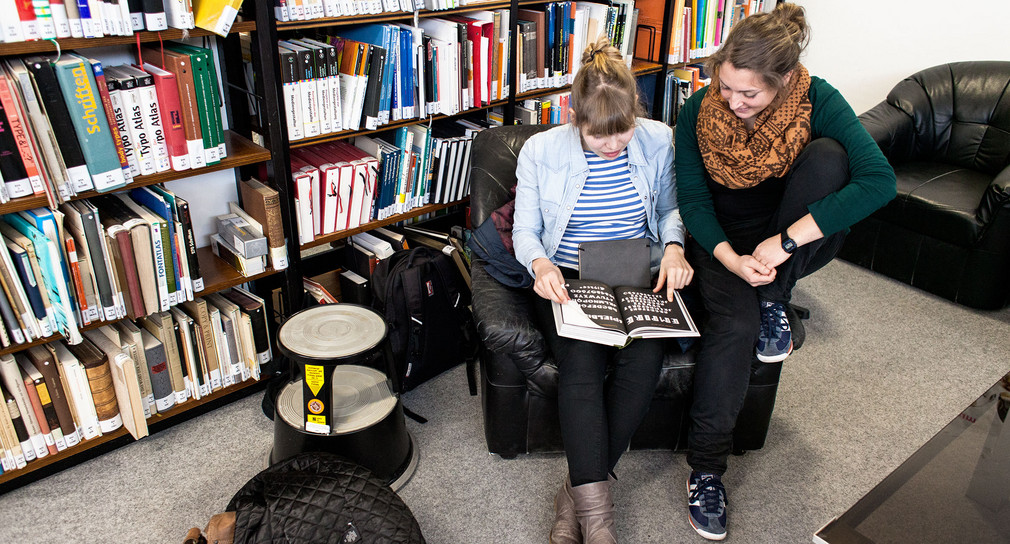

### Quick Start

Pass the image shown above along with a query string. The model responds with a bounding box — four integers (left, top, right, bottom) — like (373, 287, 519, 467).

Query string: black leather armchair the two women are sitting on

(470, 125, 782, 458)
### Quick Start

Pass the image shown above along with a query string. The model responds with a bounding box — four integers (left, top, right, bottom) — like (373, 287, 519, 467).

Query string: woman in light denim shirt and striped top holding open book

(512, 37, 694, 544)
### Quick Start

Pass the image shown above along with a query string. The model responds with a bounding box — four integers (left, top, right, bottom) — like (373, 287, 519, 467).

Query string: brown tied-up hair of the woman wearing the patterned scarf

(705, 2, 810, 98)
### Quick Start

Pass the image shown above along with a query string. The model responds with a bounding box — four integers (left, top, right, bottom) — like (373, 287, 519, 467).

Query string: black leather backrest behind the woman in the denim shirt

(470, 125, 553, 228)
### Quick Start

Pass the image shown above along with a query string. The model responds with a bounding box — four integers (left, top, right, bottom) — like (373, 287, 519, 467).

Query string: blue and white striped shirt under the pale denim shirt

(554, 148, 646, 268)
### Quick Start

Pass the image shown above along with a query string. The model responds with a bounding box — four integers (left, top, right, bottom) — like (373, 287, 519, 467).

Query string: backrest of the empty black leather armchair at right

(887, 61, 1010, 176)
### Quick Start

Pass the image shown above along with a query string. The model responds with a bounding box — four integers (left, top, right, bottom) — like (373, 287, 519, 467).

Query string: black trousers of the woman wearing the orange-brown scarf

(688, 138, 848, 474)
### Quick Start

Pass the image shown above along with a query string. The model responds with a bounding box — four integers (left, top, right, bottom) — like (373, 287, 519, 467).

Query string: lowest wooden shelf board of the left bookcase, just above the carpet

(0, 379, 266, 494)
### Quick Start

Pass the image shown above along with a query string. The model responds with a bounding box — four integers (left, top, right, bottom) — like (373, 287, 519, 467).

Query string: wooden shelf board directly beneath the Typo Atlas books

(0, 130, 270, 214)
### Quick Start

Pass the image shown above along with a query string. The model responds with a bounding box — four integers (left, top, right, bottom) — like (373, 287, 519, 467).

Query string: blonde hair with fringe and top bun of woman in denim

(572, 35, 644, 136)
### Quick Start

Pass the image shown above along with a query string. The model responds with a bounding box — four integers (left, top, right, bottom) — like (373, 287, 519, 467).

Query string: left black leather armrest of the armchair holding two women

(471, 260, 558, 395)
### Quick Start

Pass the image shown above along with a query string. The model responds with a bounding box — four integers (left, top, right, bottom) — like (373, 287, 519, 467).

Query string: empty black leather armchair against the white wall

(839, 62, 1010, 310)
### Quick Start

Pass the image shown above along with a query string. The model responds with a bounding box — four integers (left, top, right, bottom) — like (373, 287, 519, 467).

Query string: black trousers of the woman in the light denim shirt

(534, 297, 664, 485)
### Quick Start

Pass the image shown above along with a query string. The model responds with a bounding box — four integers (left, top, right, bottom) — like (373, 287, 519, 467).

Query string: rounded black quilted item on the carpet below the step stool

(227, 452, 424, 544)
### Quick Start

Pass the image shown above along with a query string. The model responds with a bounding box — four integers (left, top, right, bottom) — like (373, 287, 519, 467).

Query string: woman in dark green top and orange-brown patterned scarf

(675, 3, 895, 540)
